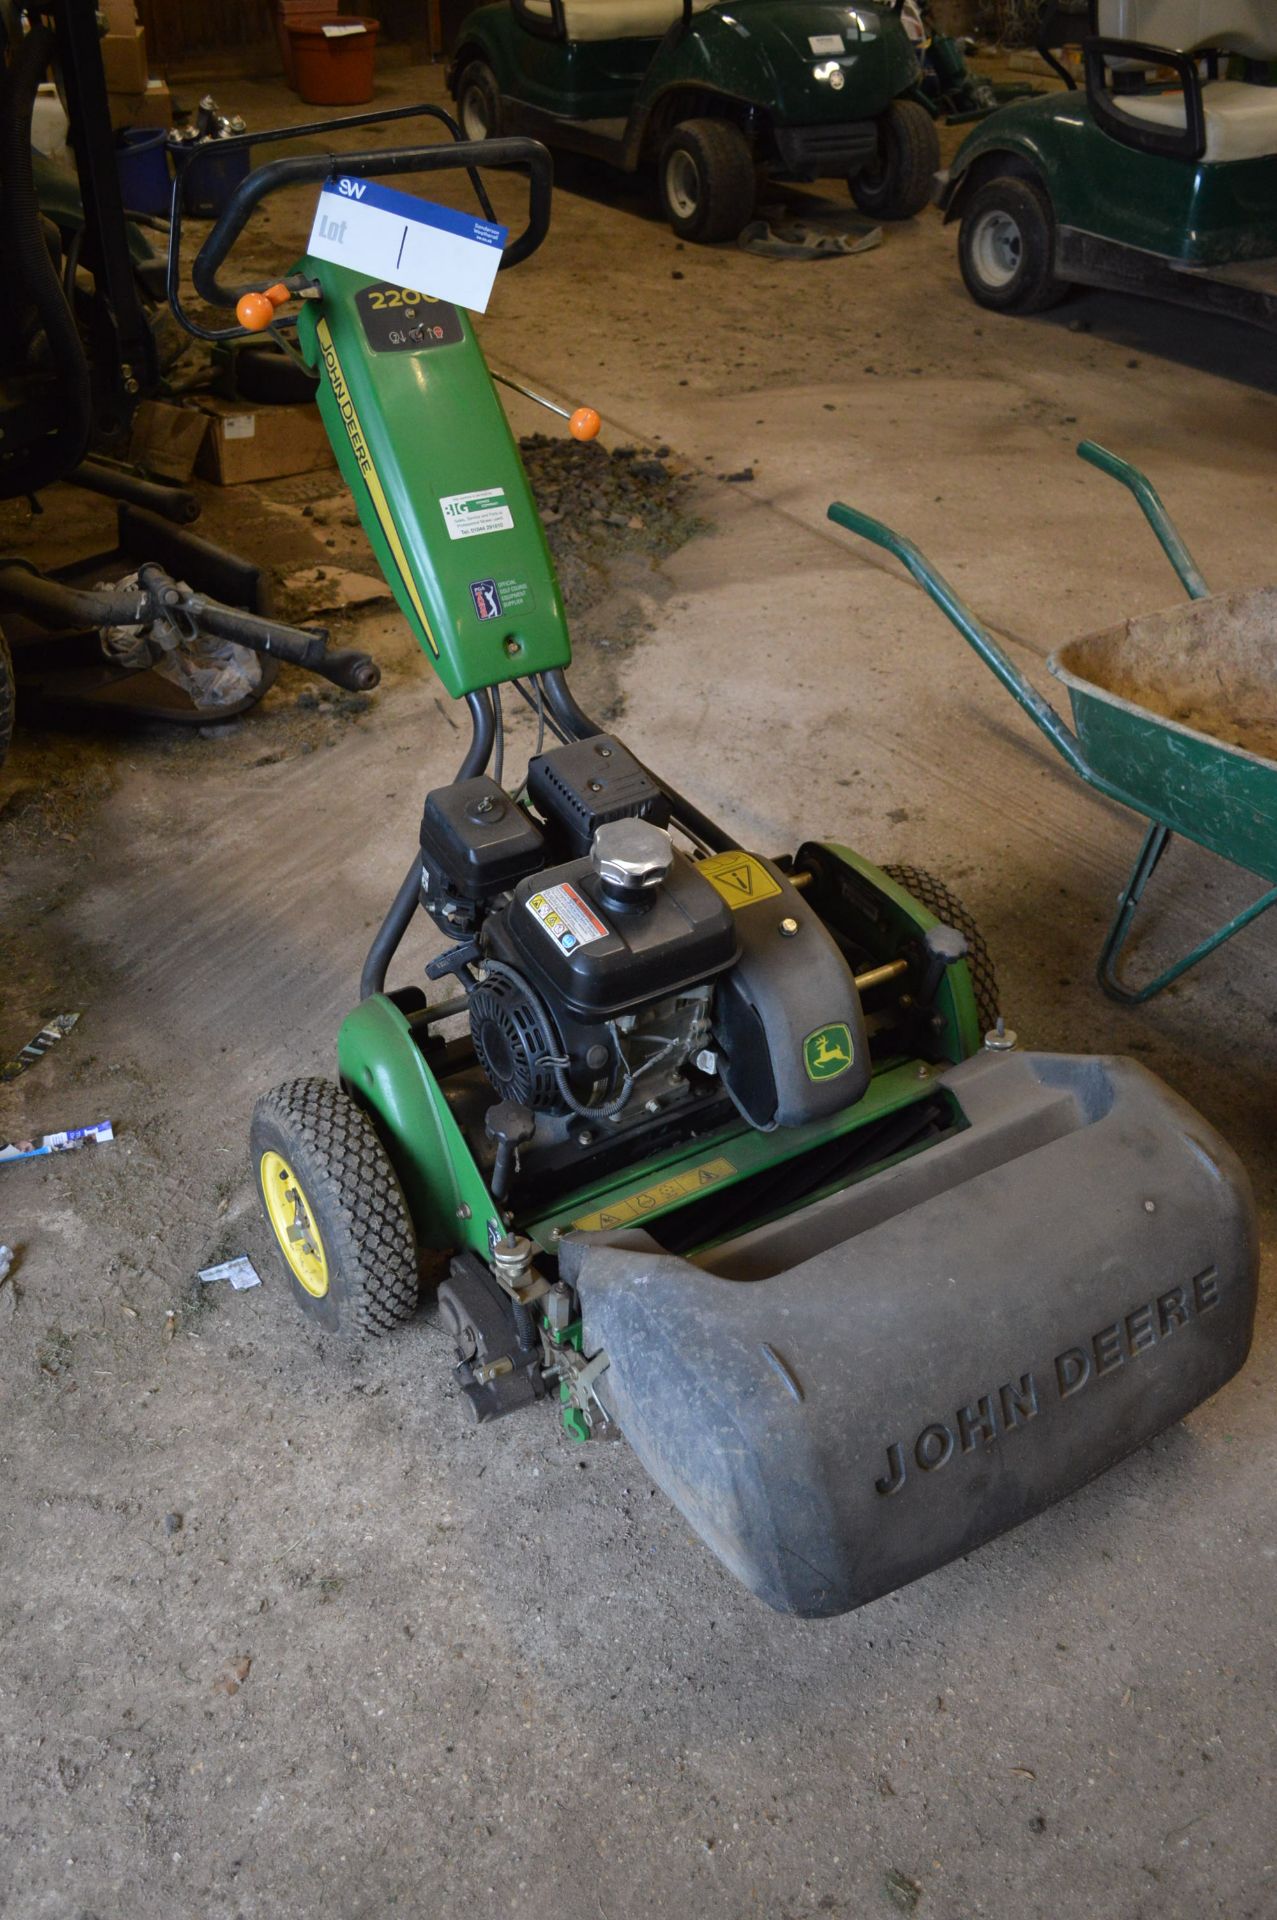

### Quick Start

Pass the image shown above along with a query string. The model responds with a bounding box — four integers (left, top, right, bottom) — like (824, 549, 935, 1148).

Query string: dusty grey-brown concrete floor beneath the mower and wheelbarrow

(0, 60, 1277, 1920)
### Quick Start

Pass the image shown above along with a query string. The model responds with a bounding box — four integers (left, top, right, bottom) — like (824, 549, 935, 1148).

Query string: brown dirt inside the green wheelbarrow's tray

(1058, 588, 1277, 760)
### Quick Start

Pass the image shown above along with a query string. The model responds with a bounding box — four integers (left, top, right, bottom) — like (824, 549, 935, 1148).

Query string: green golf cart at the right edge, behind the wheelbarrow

(937, 0, 1277, 326)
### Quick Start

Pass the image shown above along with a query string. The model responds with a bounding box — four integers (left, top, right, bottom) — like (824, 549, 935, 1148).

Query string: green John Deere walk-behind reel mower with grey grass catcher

(168, 120, 1256, 1615)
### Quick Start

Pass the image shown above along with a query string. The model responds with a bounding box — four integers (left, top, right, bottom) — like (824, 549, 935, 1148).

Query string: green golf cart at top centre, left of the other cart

(447, 0, 939, 242)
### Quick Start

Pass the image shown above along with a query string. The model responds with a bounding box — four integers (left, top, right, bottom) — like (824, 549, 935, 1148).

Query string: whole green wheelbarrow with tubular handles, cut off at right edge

(830, 440, 1277, 1006)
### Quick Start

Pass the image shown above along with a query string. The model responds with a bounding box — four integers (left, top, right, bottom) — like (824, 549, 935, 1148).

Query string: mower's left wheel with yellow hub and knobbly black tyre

(250, 1079, 419, 1338)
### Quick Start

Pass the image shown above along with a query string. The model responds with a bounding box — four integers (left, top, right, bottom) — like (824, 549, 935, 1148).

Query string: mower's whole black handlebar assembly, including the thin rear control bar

(167, 108, 553, 340)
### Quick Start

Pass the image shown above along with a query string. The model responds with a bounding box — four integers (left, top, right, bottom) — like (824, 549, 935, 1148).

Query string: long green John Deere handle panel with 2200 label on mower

(298, 255, 572, 697)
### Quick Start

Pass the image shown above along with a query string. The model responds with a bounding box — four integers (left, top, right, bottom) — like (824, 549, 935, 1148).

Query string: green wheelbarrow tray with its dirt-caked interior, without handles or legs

(1047, 588, 1277, 881)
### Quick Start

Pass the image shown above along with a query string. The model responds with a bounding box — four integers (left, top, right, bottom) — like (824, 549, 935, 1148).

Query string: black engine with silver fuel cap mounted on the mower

(412, 735, 868, 1142)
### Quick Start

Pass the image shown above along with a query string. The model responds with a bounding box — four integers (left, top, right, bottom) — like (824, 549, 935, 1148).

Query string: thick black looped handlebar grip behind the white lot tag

(190, 138, 553, 307)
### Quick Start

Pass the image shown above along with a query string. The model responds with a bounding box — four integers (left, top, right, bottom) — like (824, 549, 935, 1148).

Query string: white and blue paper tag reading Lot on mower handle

(307, 175, 509, 313)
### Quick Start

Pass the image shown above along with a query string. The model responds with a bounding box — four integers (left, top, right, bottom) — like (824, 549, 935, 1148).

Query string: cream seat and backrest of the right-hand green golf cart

(1098, 0, 1277, 161)
